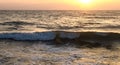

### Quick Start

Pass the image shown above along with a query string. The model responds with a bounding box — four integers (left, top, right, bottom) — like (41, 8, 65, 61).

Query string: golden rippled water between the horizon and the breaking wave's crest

(0, 10, 120, 33)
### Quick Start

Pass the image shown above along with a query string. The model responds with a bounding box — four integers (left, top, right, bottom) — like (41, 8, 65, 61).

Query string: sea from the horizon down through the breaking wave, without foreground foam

(0, 10, 120, 40)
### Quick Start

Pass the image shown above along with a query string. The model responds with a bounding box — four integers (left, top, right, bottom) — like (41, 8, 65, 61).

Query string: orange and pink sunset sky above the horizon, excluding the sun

(0, 0, 120, 10)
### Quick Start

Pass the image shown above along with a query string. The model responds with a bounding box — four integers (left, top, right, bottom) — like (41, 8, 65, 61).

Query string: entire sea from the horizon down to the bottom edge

(0, 10, 120, 65)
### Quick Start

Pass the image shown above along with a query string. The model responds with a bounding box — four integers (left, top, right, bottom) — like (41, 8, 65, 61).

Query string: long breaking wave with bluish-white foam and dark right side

(0, 31, 120, 41)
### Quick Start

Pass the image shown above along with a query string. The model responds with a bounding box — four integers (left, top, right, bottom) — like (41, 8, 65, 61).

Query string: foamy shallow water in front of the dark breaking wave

(0, 40, 120, 65)
